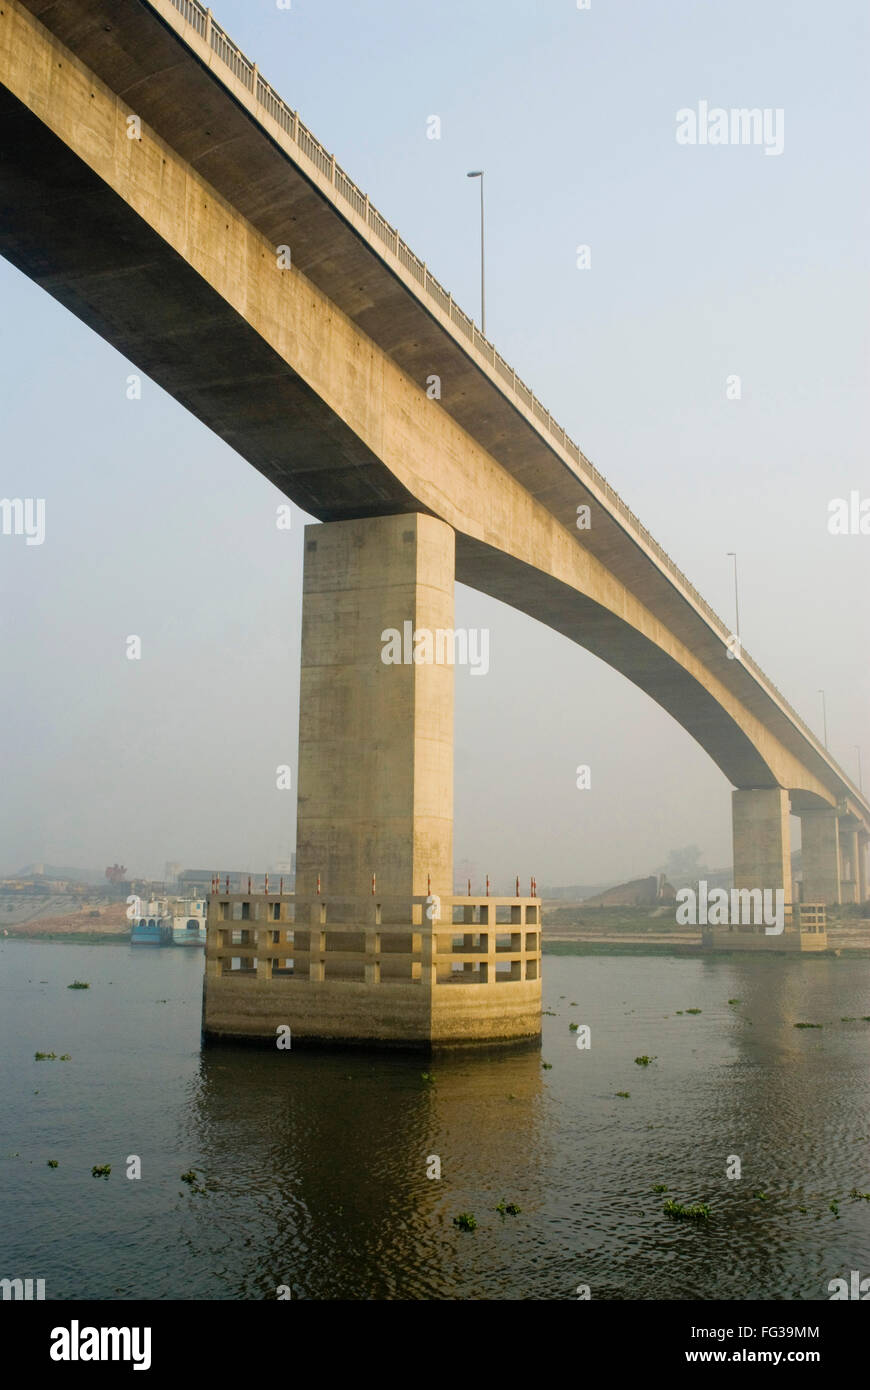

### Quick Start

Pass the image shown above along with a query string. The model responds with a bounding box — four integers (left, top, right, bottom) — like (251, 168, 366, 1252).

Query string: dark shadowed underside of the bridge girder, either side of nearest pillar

(0, 88, 824, 803)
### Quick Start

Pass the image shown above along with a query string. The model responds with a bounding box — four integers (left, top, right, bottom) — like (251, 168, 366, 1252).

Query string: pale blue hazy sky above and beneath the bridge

(0, 0, 870, 883)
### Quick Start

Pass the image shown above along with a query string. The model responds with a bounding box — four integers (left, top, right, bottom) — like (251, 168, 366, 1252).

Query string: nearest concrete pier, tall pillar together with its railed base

(203, 514, 541, 1049)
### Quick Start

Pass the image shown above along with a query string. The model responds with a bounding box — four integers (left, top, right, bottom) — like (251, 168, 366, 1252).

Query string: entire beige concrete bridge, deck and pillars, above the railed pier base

(0, 0, 870, 1037)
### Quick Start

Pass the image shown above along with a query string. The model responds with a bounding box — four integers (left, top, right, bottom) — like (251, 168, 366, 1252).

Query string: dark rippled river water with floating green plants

(0, 941, 870, 1300)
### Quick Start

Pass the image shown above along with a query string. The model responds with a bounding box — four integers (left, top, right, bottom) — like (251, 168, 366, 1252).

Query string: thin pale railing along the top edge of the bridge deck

(157, 0, 851, 785)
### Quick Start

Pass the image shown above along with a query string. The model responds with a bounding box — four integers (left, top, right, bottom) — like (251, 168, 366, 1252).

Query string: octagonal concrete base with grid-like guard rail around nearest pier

(203, 892, 541, 1051)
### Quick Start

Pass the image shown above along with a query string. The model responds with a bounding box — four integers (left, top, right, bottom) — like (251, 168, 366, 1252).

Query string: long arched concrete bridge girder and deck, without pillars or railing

(0, 0, 870, 824)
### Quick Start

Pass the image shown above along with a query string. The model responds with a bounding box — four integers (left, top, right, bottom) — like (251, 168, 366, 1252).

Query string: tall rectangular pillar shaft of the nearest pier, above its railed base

(296, 514, 456, 922)
